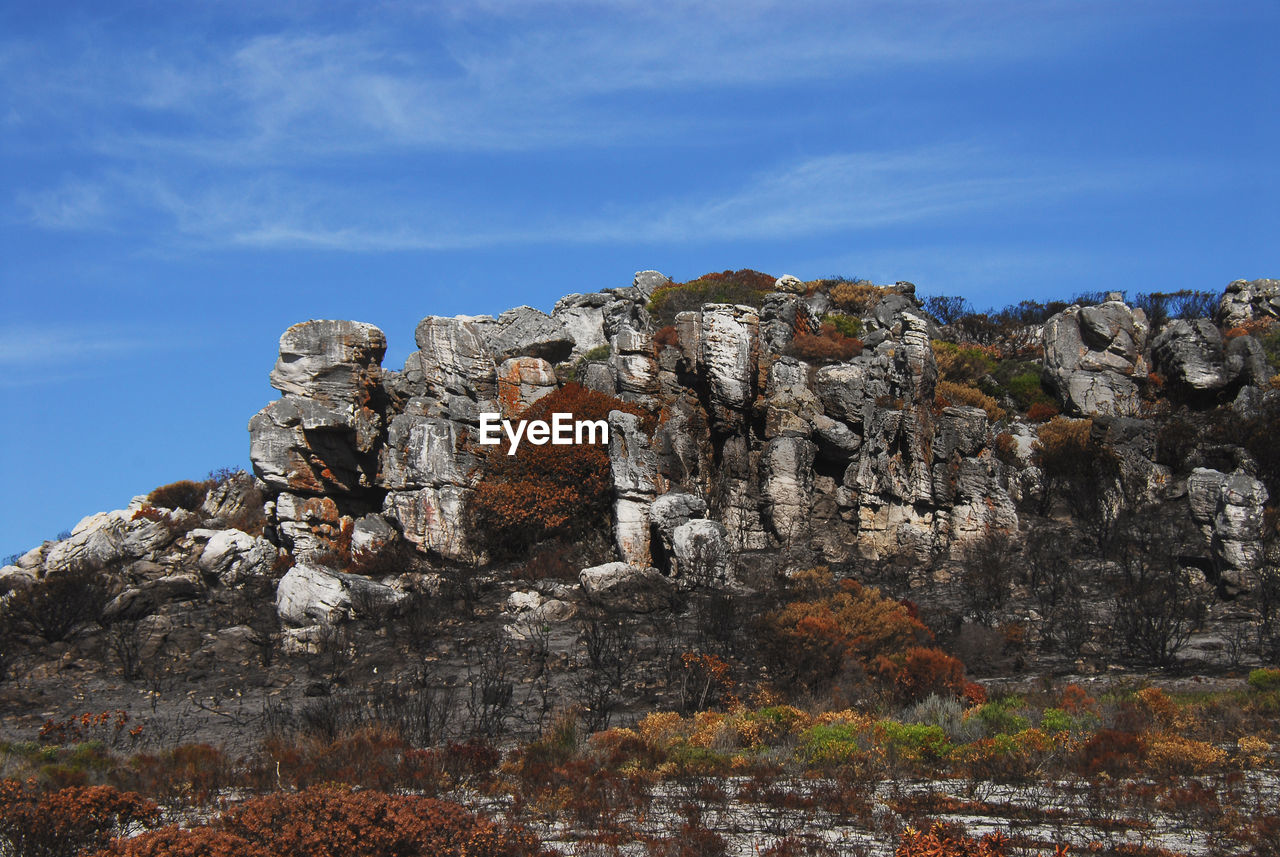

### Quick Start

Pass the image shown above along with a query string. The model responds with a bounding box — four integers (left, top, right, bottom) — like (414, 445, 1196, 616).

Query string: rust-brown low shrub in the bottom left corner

(0, 780, 160, 857)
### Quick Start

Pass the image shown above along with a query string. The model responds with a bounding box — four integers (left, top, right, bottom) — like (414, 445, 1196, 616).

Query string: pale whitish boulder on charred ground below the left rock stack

(275, 562, 404, 625)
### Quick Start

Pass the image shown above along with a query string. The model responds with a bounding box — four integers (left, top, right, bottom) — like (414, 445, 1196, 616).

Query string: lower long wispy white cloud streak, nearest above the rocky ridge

(28, 146, 1156, 252)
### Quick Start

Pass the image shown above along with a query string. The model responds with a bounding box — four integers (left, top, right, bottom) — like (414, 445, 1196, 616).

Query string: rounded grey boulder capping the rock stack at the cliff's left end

(271, 321, 387, 405)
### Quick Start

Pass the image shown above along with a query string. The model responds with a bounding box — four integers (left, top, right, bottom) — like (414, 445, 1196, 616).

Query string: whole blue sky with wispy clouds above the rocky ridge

(0, 0, 1280, 554)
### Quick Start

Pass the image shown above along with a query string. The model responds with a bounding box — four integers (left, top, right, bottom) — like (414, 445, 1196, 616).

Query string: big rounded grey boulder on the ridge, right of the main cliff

(1043, 299, 1148, 417)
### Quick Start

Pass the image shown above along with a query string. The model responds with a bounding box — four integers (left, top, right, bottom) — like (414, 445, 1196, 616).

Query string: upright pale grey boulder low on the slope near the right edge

(1187, 467, 1268, 588)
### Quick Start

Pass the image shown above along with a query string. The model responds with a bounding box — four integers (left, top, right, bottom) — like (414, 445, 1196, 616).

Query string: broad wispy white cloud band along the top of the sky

(0, 0, 1172, 162)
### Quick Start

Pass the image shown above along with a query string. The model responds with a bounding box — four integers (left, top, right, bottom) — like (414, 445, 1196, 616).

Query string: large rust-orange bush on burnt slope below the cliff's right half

(764, 569, 964, 700)
